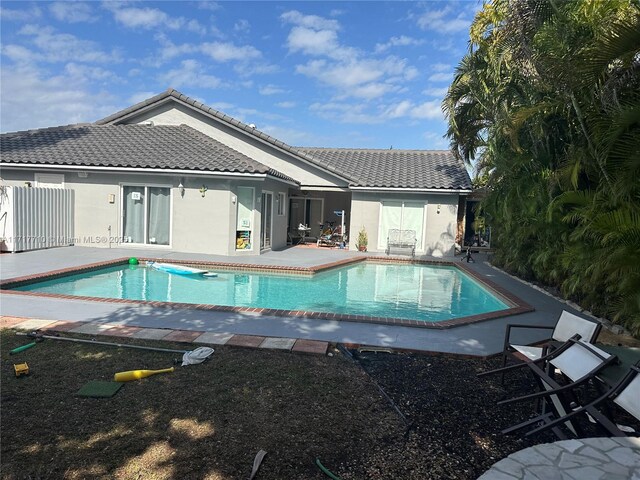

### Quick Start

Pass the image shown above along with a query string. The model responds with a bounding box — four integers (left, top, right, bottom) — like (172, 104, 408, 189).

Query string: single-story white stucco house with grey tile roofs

(0, 89, 471, 256)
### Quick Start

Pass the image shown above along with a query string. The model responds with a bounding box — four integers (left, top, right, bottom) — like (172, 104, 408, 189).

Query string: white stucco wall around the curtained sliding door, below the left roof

(2, 167, 288, 255)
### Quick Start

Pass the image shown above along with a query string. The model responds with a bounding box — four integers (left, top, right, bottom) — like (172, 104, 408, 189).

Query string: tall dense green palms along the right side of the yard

(443, 0, 640, 332)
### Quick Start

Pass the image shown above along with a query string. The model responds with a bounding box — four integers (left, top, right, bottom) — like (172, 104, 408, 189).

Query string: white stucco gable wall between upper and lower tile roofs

(120, 101, 347, 187)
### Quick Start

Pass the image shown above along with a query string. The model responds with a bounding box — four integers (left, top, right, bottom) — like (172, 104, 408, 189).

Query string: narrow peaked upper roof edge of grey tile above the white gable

(95, 88, 353, 181)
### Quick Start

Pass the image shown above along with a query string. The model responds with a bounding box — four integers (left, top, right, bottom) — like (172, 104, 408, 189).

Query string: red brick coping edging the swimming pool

(0, 256, 535, 330)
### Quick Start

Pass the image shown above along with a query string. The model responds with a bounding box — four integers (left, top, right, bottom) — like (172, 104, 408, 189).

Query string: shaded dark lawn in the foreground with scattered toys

(0, 329, 550, 480)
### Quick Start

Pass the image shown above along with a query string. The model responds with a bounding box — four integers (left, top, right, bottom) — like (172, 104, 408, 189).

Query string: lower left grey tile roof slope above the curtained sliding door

(0, 124, 298, 183)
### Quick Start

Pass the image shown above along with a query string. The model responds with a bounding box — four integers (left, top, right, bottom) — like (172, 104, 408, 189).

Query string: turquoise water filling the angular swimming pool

(12, 262, 508, 322)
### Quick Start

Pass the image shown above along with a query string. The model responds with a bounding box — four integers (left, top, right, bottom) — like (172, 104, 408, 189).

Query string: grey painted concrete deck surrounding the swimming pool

(0, 247, 600, 356)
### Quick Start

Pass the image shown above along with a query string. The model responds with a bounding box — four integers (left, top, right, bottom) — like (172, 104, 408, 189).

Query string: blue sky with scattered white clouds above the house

(0, 0, 481, 149)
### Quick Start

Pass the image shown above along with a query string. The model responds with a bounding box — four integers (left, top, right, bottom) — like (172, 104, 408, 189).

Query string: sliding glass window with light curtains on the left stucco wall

(122, 185, 171, 245)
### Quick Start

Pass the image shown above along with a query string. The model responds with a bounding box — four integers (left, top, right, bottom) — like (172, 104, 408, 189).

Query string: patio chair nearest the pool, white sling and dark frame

(479, 310, 602, 382)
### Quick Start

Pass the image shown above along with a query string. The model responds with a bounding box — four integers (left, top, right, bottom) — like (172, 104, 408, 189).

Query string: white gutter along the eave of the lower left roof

(0, 162, 300, 187)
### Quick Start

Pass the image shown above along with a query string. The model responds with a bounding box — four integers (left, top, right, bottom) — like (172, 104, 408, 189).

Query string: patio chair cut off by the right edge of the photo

(526, 362, 640, 437)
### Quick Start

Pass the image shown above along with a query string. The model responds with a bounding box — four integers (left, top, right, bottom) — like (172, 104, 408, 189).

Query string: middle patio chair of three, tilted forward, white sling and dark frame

(498, 335, 617, 439)
